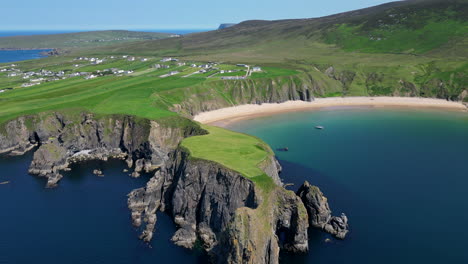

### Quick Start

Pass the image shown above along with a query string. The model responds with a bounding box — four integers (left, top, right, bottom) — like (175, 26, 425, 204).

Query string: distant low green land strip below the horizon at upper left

(0, 30, 171, 49)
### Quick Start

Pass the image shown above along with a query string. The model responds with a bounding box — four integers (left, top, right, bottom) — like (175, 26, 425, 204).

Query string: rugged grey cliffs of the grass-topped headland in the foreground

(128, 148, 308, 263)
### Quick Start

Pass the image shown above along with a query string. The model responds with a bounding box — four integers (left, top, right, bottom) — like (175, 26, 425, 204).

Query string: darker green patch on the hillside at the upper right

(325, 1, 468, 55)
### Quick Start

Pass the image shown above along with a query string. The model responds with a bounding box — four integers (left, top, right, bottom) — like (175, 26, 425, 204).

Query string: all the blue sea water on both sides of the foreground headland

(0, 109, 468, 264)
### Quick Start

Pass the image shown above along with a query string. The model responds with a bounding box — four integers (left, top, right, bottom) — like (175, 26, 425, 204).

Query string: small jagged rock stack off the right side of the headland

(297, 181, 348, 239)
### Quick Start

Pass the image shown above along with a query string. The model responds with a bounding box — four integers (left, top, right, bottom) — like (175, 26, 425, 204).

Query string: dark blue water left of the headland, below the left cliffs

(0, 154, 206, 264)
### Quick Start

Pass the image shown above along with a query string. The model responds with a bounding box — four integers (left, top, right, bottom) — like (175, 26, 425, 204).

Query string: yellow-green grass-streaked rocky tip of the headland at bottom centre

(217, 188, 308, 263)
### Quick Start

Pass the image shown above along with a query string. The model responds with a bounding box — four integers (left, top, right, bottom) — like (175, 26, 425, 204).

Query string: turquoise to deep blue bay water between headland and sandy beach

(226, 108, 468, 264)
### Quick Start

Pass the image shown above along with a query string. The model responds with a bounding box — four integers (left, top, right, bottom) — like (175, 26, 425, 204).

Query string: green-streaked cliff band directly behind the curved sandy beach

(164, 65, 468, 117)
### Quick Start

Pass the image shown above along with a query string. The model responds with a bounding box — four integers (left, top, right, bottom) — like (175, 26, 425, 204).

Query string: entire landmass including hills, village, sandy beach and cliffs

(0, 0, 468, 264)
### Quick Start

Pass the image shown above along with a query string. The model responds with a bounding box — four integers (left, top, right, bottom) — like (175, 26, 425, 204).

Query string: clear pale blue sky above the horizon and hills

(0, 0, 396, 30)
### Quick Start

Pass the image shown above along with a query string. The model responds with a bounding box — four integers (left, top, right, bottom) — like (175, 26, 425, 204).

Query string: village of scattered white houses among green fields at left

(0, 55, 262, 93)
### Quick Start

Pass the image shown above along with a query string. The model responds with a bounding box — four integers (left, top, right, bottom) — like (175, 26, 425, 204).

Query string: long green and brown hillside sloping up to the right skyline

(83, 0, 468, 58)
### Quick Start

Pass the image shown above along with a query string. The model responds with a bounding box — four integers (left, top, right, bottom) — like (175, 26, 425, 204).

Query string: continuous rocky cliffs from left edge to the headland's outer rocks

(0, 110, 348, 263)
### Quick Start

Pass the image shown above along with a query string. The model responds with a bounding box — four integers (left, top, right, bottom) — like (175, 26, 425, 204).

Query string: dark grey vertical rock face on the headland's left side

(128, 150, 257, 248)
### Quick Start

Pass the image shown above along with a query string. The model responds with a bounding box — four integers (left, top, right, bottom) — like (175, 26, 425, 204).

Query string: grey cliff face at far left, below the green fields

(0, 113, 206, 187)
